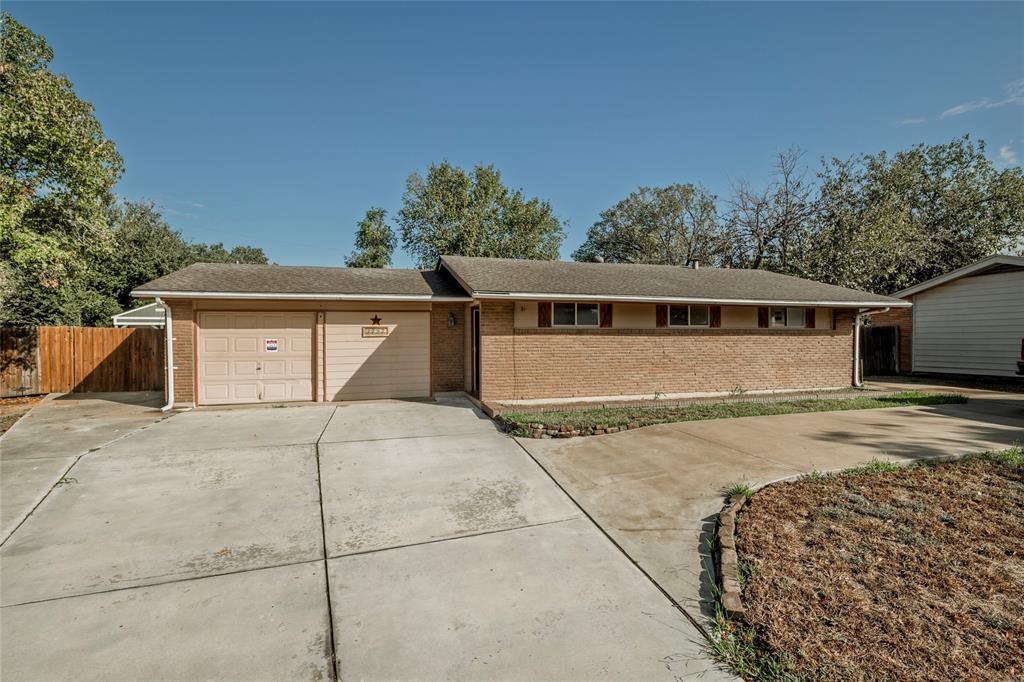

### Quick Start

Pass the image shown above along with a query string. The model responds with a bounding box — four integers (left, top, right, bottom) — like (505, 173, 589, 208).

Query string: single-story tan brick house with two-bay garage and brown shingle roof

(132, 256, 910, 406)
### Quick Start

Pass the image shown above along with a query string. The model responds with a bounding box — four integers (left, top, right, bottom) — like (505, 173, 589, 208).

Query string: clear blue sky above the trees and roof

(5, 2, 1024, 265)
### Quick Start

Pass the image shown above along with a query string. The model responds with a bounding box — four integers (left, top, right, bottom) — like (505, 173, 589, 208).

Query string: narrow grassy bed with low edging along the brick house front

(501, 391, 967, 435)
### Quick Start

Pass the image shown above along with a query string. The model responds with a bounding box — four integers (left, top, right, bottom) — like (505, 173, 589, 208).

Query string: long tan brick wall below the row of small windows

(480, 301, 853, 401)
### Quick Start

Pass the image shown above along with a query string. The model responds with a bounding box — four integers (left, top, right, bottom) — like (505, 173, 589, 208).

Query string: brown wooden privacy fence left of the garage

(0, 327, 164, 397)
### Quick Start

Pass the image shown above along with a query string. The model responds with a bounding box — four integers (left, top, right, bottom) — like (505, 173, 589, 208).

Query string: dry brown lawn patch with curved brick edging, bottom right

(724, 447, 1024, 680)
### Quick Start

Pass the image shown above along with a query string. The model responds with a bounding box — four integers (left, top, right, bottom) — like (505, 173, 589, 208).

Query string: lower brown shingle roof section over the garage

(132, 263, 468, 301)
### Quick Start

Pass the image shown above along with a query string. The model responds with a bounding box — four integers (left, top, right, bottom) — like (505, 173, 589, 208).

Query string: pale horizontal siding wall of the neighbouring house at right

(913, 271, 1024, 377)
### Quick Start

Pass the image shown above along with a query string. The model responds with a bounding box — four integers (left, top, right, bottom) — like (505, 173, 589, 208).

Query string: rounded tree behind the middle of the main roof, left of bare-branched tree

(572, 184, 728, 265)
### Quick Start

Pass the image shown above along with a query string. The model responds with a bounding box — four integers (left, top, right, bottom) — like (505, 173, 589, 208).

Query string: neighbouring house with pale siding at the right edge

(871, 254, 1024, 377)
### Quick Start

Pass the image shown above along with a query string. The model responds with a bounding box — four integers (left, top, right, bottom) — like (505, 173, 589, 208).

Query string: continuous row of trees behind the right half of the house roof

(573, 136, 1024, 294)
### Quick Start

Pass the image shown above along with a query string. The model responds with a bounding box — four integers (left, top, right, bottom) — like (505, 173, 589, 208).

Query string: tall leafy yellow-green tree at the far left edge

(0, 12, 122, 292)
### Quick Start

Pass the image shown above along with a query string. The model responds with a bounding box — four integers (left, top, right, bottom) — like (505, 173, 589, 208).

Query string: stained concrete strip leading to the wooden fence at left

(0, 392, 165, 542)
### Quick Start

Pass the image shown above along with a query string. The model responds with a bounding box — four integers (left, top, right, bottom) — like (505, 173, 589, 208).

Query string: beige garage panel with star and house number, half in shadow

(325, 311, 430, 400)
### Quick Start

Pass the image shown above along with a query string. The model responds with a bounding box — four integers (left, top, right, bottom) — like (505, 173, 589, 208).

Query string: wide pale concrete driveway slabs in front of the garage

(0, 399, 728, 680)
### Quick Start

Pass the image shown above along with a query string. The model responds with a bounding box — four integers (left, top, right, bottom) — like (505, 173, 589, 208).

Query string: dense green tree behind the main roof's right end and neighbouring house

(795, 136, 1024, 293)
